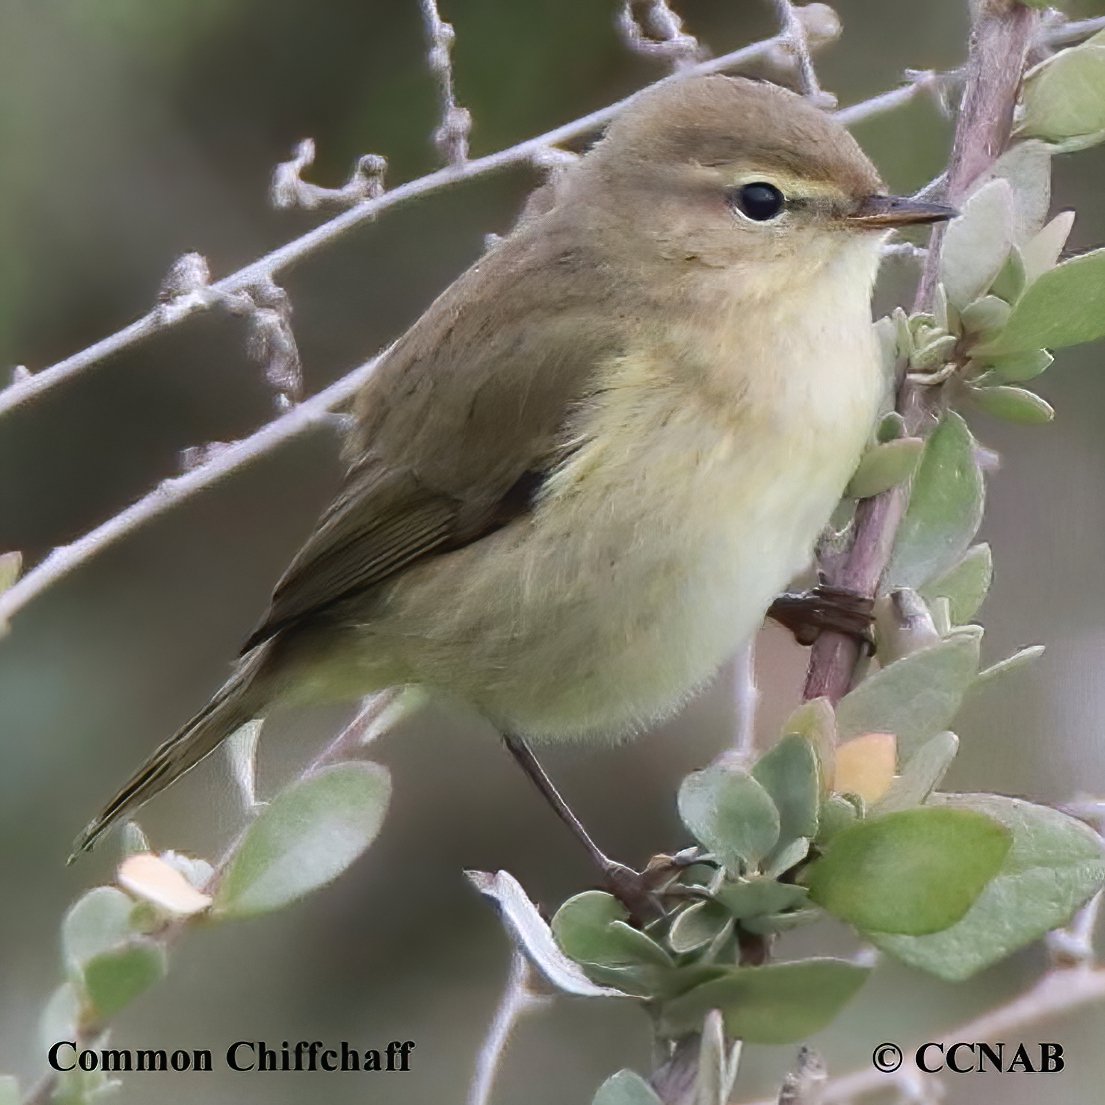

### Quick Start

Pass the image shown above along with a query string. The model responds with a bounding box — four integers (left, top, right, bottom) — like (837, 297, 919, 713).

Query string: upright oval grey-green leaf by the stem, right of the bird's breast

(886, 411, 983, 589)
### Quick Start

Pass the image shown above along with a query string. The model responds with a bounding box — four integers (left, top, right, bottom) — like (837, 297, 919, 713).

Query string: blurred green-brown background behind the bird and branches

(0, 0, 1105, 1105)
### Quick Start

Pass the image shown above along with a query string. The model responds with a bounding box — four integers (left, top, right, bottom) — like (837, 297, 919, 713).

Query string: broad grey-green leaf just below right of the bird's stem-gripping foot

(836, 629, 979, 758)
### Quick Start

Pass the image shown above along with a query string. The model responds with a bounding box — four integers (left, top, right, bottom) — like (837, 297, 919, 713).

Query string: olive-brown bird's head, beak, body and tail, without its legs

(75, 76, 954, 851)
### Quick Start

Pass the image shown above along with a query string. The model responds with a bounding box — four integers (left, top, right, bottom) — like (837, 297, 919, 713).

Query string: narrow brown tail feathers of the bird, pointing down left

(69, 648, 267, 863)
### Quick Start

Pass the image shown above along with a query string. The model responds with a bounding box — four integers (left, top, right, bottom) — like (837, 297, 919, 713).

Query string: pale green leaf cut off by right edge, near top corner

(1018, 43, 1105, 145)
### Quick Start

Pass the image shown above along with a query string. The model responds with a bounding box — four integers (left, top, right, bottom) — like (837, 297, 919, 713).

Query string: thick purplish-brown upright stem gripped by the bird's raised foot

(804, 0, 1040, 702)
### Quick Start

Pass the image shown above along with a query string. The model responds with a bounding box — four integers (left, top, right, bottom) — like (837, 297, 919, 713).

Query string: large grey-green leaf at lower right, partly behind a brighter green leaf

(867, 794, 1105, 981)
